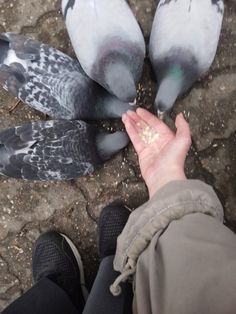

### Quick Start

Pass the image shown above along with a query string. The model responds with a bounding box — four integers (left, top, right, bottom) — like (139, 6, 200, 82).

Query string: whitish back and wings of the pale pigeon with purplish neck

(62, 0, 145, 76)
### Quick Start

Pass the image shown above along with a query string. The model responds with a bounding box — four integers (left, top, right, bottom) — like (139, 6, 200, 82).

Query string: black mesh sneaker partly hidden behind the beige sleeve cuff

(98, 202, 131, 260)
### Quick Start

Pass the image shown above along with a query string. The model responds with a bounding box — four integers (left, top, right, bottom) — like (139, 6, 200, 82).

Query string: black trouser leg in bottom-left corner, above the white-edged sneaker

(2, 278, 79, 314)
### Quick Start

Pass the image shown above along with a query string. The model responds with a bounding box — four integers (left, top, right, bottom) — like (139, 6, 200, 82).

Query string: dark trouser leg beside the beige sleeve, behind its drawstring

(83, 256, 132, 314)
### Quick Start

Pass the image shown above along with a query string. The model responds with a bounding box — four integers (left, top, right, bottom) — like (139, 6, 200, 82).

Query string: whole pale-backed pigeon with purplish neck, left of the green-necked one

(62, 0, 146, 103)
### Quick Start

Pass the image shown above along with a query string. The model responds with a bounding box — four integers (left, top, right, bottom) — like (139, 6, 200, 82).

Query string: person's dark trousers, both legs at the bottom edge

(1, 256, 133, 314)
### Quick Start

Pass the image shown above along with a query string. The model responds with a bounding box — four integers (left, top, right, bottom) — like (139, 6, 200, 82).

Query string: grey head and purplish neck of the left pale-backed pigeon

(91, 37, 144, 102)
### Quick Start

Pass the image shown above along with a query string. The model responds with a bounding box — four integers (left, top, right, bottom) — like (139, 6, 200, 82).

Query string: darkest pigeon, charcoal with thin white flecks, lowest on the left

(0, 120, 129, 181)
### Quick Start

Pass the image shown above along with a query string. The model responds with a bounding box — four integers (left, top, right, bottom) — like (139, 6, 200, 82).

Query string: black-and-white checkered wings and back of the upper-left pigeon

(0, 33, 88, 119)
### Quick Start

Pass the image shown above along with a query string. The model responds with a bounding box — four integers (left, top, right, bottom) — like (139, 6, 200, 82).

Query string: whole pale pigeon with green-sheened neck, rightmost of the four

(149, 0, 224, 115)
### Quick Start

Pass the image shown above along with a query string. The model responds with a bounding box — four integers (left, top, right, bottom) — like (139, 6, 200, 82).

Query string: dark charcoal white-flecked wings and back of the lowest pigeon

(0, 121, 94, 181)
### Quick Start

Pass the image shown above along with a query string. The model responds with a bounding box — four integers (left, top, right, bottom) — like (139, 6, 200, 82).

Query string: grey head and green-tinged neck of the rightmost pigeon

(155, 66, 184, 116)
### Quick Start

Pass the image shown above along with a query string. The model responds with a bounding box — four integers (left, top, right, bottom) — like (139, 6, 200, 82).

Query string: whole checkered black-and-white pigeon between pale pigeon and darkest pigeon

(0, 33, 132, 120)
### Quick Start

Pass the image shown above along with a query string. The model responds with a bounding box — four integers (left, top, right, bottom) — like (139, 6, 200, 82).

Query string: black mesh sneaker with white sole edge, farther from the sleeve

(33, 231, 88, 312)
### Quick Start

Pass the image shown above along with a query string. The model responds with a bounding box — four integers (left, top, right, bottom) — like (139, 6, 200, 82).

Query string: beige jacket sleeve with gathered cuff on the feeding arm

(114, 180, 236, 314)
